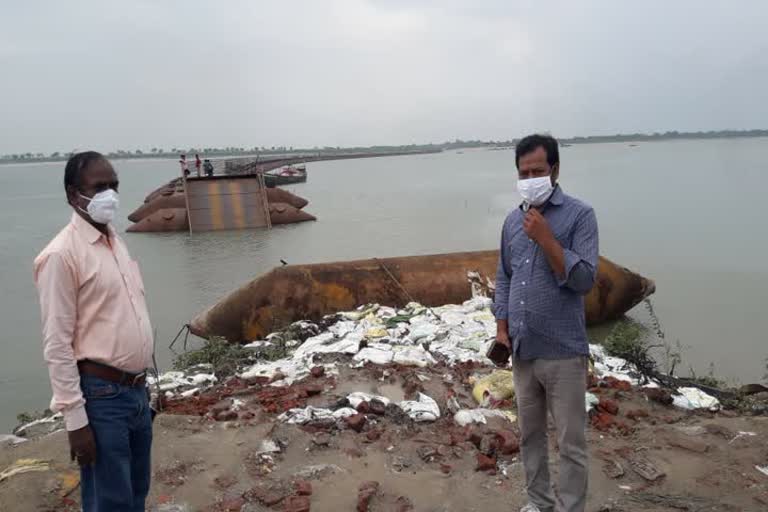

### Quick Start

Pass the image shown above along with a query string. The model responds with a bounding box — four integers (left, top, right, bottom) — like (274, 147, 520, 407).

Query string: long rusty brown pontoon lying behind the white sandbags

(189, 251, 656, 343)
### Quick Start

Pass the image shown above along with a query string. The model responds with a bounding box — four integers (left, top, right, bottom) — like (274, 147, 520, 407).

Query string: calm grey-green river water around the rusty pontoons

(0, 139, 768, 433)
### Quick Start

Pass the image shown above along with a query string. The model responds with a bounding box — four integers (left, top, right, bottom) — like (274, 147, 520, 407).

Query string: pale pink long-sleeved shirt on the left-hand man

(34, 213, 153, 430)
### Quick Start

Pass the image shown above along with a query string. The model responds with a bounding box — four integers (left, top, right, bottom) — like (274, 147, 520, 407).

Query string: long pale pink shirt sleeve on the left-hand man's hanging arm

(34, 252, 88, 431)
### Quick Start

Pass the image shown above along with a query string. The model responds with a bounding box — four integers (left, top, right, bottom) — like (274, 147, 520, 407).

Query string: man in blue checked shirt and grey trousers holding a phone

(494, 135, 598, 512)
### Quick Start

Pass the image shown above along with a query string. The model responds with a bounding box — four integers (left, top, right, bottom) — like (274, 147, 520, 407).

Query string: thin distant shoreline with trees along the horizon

(0, 130, 768, 165)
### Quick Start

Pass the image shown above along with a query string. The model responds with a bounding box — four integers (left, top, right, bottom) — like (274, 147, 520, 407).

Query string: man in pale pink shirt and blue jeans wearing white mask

(34, 151, 153, 512)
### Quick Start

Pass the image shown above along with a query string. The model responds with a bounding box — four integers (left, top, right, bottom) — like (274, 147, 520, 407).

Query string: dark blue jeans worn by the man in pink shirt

(80, 375, 152, 512)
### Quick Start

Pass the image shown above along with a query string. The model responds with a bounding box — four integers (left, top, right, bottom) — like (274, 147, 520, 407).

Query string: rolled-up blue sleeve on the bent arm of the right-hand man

(558, 208, 600, 295)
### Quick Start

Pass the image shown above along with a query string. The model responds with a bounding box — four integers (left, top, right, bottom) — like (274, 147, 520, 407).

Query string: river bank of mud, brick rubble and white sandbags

(0, 298, 768, 511)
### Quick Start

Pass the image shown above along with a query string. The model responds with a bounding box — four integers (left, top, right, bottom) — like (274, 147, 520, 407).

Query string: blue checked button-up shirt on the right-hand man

(494, 185, 598, 360)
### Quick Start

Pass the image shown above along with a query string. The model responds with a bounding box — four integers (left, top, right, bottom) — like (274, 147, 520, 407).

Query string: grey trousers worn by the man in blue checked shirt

(512, 357, 587, 512)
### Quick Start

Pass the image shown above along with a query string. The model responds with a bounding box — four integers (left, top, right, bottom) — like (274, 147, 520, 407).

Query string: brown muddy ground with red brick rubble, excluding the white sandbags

(0, 364, 768, 512)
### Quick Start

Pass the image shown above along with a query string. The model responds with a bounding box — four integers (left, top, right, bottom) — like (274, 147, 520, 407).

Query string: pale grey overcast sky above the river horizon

(0, 0, 768, 153)
